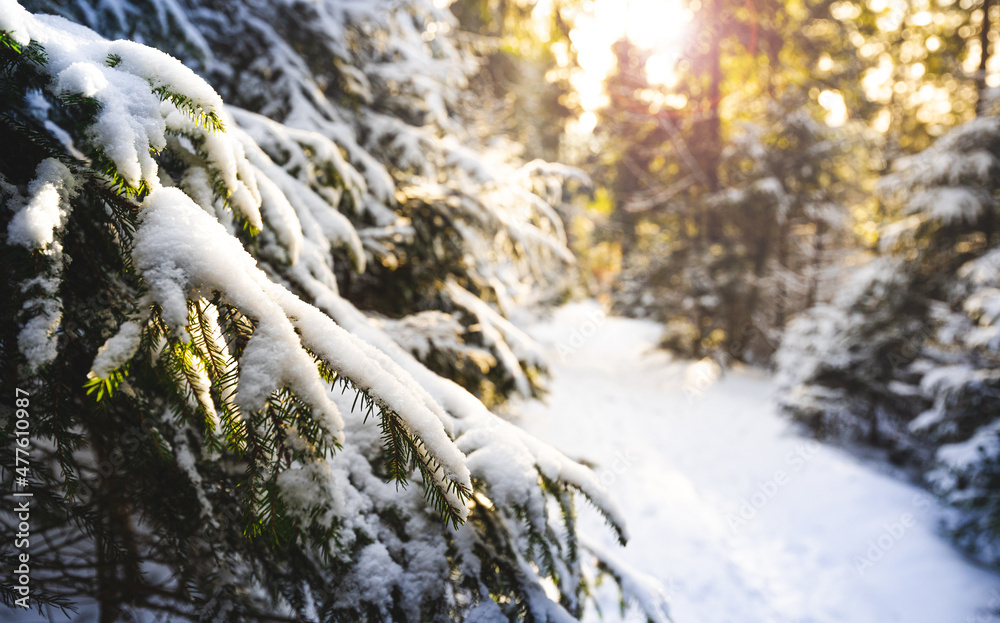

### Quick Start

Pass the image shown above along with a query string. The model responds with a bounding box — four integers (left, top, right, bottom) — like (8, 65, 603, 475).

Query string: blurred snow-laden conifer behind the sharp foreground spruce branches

(19, 0, 587, 402)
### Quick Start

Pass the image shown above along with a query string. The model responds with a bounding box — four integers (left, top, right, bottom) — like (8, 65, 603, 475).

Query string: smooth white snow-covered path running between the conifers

(519, 303, 1000, 623)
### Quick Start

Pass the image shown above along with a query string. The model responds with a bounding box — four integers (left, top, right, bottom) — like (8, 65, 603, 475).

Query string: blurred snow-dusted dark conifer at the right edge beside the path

(779, 112, 1000, 565)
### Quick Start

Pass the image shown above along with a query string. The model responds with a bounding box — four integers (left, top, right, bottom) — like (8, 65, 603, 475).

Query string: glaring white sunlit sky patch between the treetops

(570, 0, 693, 131)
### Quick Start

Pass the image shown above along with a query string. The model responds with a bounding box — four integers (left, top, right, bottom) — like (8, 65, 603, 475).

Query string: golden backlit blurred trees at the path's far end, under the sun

(556, 0, 997, 364)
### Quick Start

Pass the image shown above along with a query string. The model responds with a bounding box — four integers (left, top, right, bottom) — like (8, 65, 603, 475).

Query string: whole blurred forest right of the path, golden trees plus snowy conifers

(497, 0, 1000, 564)
